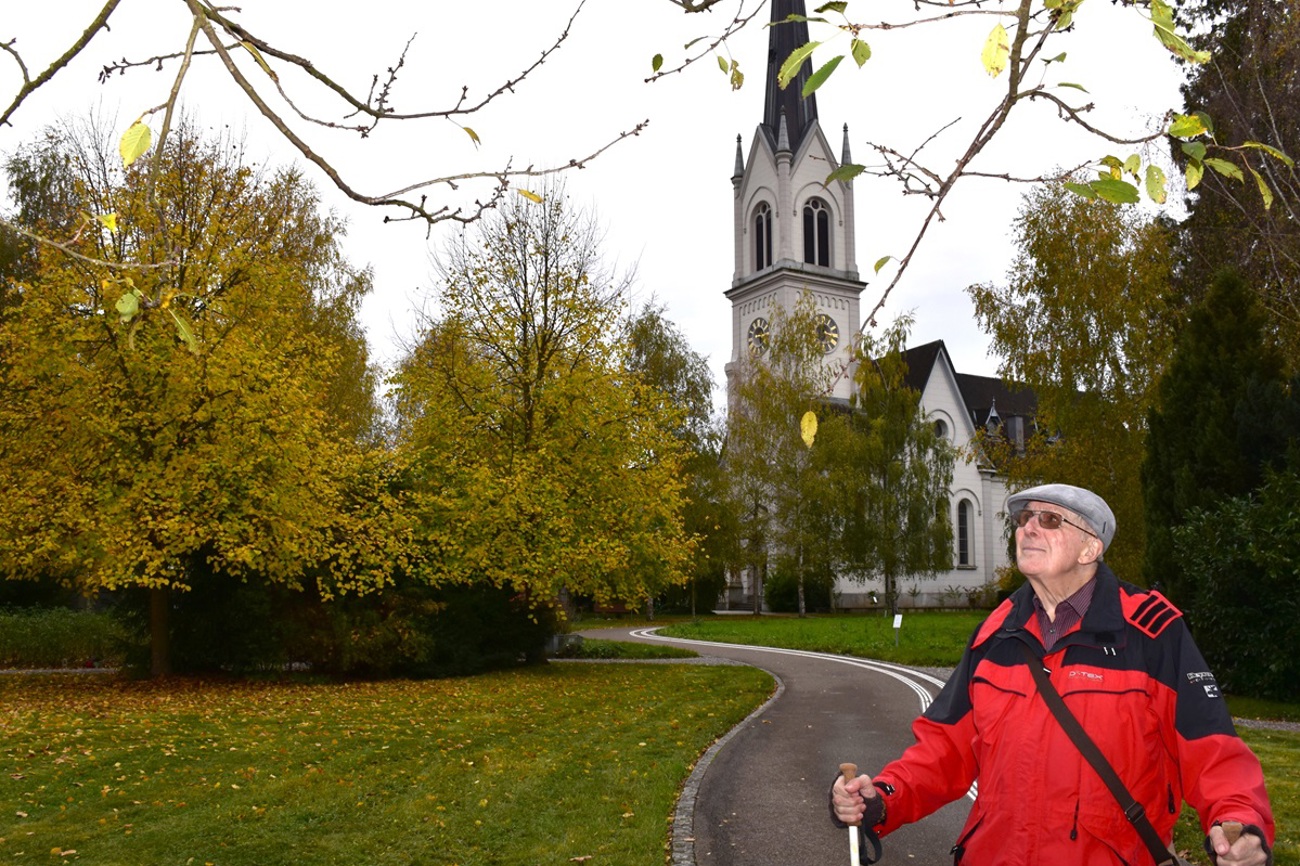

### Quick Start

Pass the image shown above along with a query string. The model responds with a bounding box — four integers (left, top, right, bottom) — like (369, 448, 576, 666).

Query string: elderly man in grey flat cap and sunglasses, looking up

(831, 484, 1274, 866)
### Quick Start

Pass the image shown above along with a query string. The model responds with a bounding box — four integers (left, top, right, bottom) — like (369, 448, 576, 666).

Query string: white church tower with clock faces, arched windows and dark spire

(725, 0, 866, 400)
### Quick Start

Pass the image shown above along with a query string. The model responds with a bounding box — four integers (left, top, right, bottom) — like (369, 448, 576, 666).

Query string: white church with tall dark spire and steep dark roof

(723, 0, 1035, 610)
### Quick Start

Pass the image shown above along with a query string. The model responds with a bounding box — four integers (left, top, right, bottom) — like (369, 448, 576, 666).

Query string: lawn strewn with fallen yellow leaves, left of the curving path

(0, 664, 772, 866)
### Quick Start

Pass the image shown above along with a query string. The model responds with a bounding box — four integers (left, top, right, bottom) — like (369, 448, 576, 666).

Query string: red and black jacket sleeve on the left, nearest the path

(874, 646, 979, 836)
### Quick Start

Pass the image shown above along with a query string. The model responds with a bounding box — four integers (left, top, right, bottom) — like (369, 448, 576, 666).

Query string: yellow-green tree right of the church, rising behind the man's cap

(967, 180, 1182, 580)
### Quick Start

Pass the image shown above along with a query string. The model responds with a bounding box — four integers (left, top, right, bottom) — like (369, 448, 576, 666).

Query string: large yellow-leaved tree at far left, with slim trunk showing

(0, 114, 395, 674)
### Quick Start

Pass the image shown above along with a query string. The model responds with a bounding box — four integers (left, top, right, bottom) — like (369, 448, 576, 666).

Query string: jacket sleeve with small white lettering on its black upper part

(1169, 620, 1274, 846)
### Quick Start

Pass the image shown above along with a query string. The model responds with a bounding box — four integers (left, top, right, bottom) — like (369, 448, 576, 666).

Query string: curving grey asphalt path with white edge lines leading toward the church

(582, 627, 971, 866)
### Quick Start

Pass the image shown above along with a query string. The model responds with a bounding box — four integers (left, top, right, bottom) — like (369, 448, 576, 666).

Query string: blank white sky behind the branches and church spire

(0, 0, 1179, 400)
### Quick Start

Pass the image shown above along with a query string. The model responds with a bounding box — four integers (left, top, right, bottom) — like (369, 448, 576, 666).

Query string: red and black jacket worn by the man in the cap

(875, 563, 1274, 866)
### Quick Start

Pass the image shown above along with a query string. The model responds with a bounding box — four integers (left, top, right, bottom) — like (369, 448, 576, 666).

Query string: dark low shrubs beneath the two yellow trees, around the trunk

(107, 570, 554, 679)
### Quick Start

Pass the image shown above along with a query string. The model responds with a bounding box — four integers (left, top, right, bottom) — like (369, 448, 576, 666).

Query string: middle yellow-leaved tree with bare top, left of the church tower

(395, 187, 692, 606)
